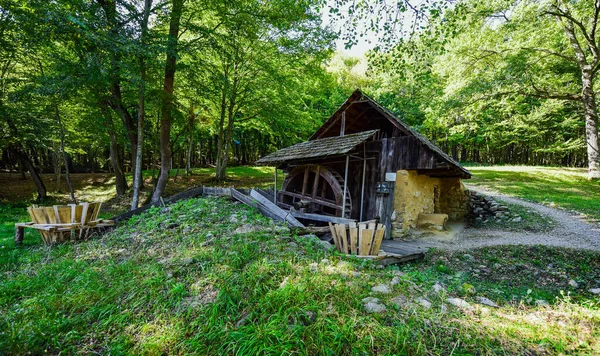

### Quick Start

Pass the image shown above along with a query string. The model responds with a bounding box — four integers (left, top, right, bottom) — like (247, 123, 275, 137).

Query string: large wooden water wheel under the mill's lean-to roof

(279, 165, 352, 218)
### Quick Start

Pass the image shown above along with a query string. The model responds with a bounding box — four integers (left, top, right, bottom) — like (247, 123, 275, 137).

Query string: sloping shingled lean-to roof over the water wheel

(256, 130, 377, 164)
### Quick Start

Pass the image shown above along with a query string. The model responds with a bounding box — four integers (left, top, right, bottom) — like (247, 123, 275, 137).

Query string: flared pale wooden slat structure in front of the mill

(329, 222, 385, 256)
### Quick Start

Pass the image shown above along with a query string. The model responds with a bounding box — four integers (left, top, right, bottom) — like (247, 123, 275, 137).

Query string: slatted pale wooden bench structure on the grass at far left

(15, 203, 114, 245)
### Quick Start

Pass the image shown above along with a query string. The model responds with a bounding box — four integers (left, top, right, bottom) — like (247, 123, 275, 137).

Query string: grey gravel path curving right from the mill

(410, 186, 600, 251)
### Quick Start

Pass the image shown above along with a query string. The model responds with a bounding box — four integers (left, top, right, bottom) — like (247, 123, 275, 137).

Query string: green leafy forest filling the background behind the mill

(0, 0, 600, 208)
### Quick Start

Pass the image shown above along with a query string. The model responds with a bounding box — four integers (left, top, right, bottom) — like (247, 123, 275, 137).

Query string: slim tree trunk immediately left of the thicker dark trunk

(131, 0, 152, 210)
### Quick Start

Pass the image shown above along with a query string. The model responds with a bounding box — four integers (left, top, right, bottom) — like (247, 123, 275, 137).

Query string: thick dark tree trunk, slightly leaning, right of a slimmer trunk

(152, 0, 183, 203)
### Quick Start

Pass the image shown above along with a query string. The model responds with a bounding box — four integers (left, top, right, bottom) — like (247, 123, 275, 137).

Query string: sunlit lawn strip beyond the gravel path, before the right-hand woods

(467, 166, 600, 220)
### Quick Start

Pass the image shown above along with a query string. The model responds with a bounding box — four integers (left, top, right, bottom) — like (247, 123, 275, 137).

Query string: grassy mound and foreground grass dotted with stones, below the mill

(0, 198, 600, 355)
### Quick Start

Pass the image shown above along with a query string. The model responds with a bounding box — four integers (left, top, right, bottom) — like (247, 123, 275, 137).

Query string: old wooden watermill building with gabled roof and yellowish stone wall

(258, 90, 471, 237)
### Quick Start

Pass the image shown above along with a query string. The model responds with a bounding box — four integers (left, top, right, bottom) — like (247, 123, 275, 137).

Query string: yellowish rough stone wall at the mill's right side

(391, 170, 469, 237)
